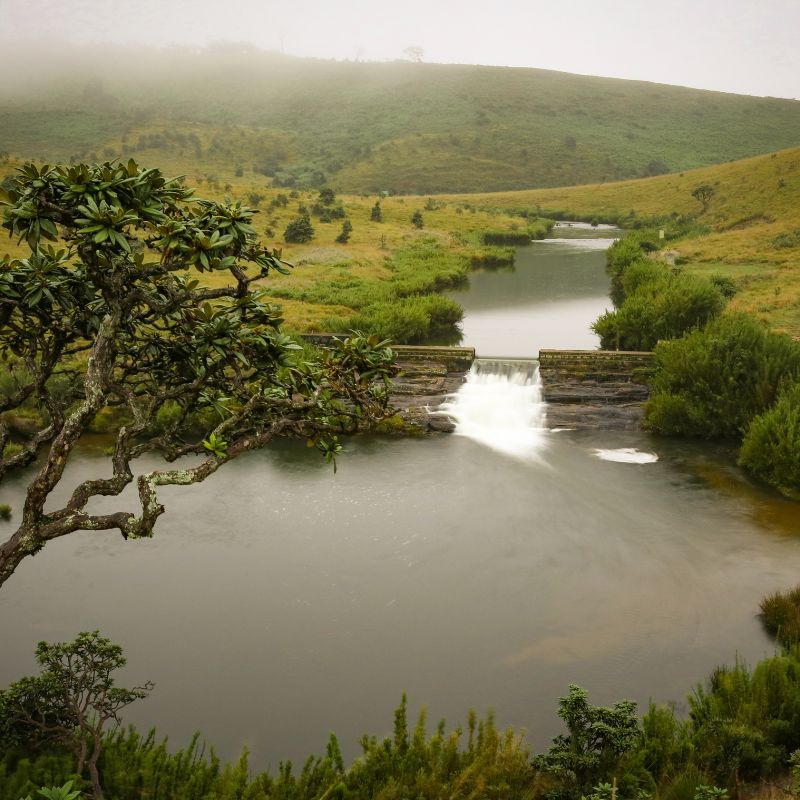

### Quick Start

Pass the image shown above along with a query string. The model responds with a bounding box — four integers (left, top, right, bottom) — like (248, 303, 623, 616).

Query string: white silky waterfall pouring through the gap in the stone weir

(439, 359, 547, 459)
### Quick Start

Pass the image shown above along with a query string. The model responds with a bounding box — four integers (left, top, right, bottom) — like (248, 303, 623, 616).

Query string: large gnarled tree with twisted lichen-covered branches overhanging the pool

(0, 161, 394, 585)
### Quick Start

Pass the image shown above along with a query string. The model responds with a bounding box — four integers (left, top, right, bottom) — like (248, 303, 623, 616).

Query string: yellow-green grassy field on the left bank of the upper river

(0, 158, 536, 334)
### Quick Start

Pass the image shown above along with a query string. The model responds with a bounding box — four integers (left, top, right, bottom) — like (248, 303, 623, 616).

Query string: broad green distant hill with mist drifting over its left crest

(0, 46, 800, 194)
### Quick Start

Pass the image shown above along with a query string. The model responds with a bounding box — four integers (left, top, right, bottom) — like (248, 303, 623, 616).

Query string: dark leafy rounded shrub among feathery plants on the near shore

(533, 684, 642, 796)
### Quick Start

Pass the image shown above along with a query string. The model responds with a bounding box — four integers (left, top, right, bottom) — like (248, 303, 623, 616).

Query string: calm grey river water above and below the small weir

(0, 223, 800, 768)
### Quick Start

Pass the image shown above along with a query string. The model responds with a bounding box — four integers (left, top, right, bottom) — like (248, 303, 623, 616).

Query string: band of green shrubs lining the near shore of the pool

(0, 632, 800, 800)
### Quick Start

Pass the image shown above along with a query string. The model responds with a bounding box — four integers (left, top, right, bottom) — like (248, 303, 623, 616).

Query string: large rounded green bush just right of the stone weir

(645, 314, 800, 438)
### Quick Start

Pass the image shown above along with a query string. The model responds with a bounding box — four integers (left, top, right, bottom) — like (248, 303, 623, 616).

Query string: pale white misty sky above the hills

(0, 0, 800, 98)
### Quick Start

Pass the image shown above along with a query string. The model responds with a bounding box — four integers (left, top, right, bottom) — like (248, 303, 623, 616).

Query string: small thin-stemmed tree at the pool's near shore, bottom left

(0, 631, 153, 799)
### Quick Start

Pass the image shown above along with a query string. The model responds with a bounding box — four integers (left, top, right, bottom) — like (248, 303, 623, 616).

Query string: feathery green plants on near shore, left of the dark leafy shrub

(0, 697, 533, 800)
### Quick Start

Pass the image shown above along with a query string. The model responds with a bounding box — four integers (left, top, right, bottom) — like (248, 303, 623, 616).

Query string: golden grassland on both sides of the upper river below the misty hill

(0, 141, 800, 337)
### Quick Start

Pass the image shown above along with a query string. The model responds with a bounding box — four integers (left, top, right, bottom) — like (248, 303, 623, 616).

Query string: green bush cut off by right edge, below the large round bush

(739, 380, 800, 499)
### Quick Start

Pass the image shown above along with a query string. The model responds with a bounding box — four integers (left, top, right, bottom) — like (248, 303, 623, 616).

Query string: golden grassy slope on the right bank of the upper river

(454, 148, 800, 337)
